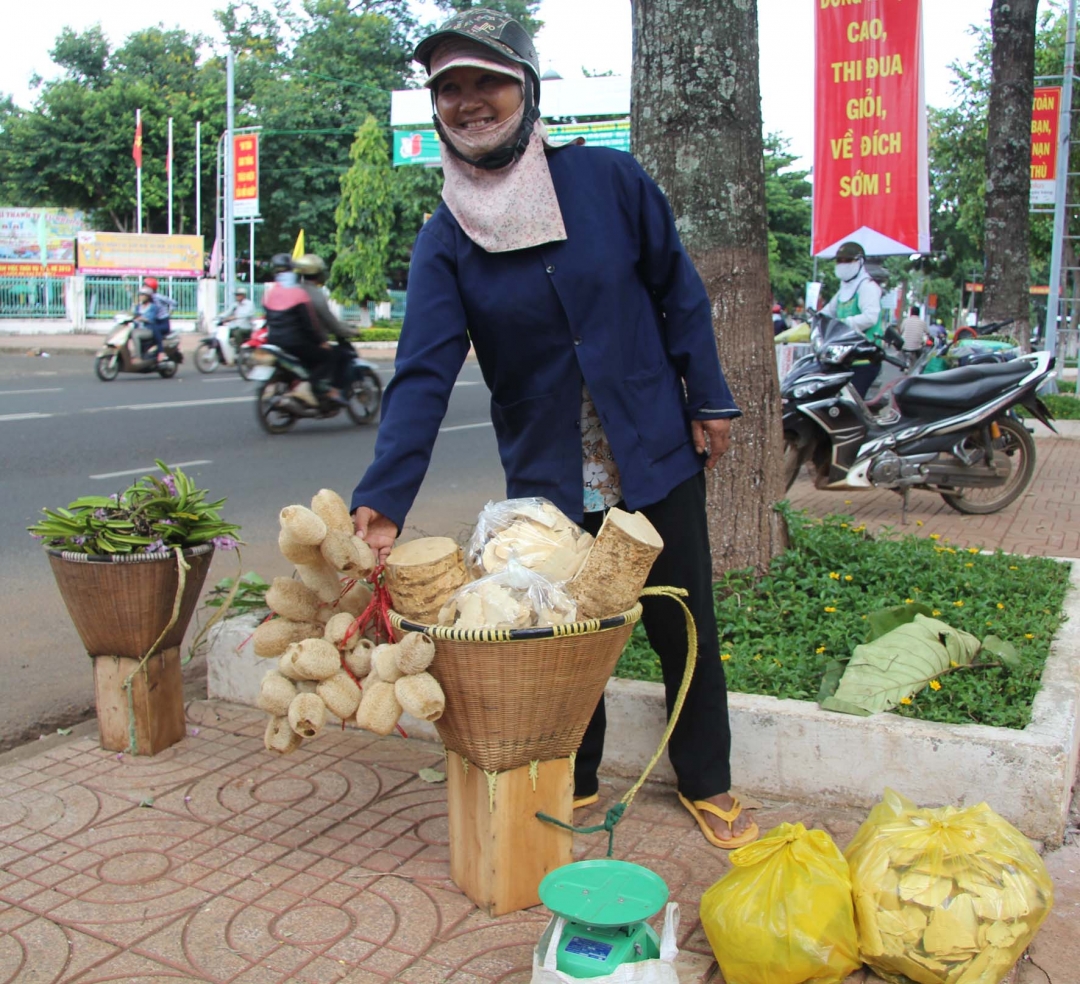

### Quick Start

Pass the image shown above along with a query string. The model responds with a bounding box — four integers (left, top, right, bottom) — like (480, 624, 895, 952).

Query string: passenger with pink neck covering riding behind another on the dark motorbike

(262, 253, 333, 406)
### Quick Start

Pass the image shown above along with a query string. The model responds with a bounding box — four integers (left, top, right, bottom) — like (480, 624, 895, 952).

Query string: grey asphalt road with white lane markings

(0, 354, 503, 749)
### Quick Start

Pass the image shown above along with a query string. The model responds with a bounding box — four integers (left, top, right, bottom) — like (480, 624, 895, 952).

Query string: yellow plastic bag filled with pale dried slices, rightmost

(846, 790, 1054, 984)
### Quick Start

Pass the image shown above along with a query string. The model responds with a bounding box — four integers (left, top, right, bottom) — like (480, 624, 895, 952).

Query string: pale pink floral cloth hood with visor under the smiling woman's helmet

(429, 40, 566, 253)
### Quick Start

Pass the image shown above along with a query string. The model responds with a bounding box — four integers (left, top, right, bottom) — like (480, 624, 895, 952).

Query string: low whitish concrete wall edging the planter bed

(208, 564, 1080, 845)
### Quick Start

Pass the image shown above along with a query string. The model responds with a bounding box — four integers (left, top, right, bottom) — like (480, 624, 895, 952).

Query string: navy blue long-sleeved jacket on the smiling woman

(352, 146, 740, 529)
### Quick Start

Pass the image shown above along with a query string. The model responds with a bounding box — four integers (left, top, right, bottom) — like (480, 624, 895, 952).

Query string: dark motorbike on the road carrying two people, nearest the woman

(248, 336, 382, 434)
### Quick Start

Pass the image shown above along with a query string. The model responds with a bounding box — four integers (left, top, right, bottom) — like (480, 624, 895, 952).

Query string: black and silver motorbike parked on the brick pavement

(781, 315, 1055, 514)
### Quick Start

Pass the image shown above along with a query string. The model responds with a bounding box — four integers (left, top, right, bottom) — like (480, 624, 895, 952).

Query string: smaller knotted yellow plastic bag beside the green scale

(701, 823, 860, 984)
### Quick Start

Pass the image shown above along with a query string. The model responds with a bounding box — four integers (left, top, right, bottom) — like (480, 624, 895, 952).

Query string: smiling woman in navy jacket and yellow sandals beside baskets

(352, 9, 757, 848)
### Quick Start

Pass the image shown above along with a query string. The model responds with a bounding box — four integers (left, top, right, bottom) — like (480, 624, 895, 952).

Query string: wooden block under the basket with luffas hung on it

(446, 752, 573, 916)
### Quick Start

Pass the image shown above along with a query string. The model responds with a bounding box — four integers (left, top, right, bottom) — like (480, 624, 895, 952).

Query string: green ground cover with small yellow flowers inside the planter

(616, 506, 1069, 728)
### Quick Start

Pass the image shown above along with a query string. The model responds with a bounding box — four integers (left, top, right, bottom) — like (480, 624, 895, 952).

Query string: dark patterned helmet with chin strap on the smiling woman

(413, 8, 540, 170)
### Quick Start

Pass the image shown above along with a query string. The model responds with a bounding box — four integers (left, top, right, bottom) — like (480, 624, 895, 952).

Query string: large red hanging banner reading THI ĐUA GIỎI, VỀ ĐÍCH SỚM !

(812, 0, 930, 257)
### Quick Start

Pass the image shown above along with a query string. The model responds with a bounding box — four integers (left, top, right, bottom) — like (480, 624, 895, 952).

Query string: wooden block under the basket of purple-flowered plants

(94, 646, 187, 755)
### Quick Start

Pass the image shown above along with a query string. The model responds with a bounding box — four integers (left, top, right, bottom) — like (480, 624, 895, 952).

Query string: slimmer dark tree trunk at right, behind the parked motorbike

(982, 0, 1038, 350)
